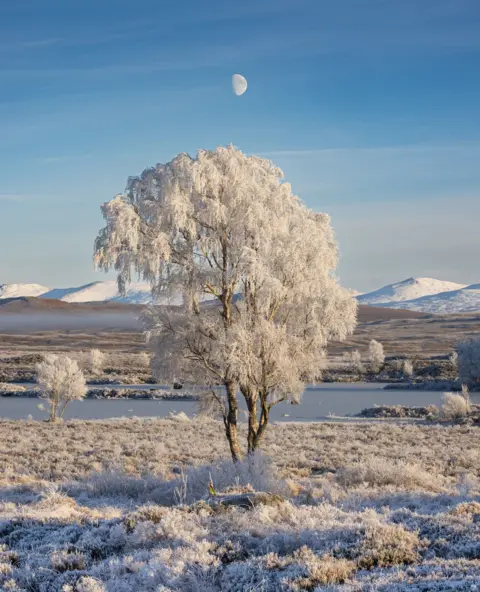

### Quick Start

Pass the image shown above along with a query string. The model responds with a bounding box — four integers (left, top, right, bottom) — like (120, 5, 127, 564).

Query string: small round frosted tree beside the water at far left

(36, 354, 87, 421)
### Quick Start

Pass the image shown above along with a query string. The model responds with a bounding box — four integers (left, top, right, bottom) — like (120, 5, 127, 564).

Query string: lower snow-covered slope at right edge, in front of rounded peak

(376, 284, 480, 314)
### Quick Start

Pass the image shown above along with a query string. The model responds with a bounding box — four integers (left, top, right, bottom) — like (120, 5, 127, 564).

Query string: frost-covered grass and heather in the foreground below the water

(0, 419, 480, 592)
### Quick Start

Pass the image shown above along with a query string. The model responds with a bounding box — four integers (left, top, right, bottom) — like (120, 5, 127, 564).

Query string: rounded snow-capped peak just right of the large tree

(357, 278, 466, 308)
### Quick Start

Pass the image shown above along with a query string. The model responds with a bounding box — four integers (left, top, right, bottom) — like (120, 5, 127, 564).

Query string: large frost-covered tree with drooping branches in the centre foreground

(95, 146, 356, 460)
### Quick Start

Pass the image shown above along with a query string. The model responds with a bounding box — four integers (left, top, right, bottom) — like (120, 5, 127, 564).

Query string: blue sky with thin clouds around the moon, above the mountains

(0, 0, 480, 291)
